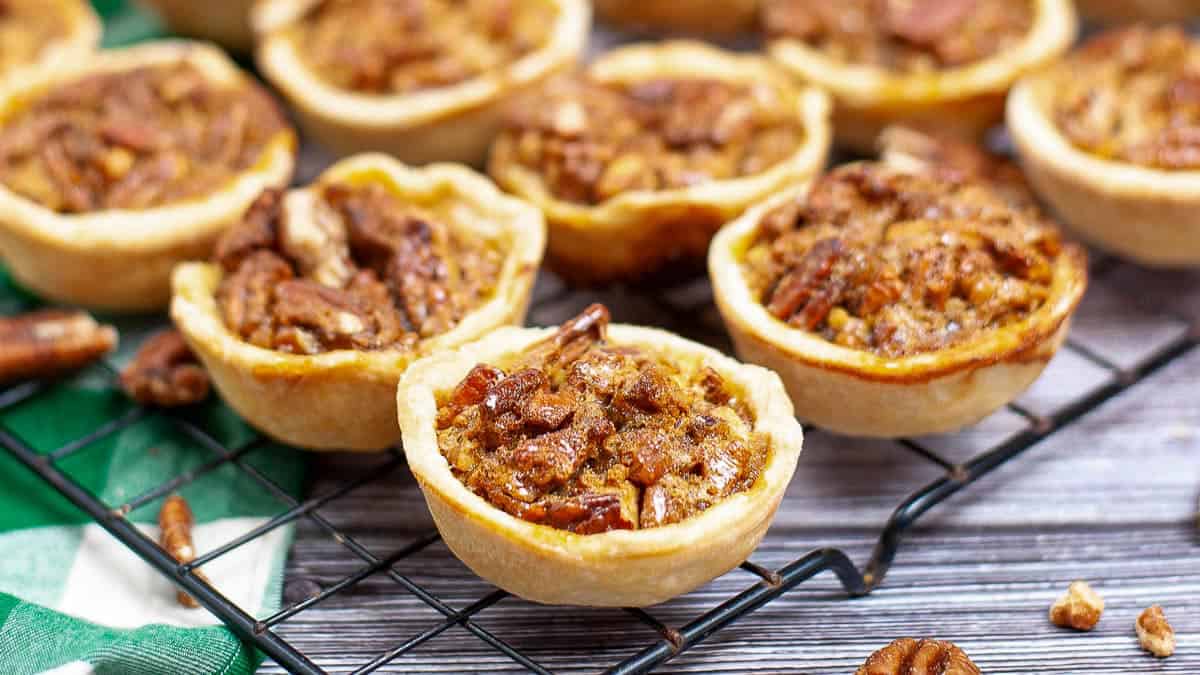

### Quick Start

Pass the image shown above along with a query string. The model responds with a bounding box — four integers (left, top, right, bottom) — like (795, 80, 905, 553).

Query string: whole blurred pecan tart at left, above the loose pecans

(0, 42, 295, 311)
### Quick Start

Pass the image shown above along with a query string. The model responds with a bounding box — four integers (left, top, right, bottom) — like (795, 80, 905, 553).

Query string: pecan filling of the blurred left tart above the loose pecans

(0, 62, 284, 214)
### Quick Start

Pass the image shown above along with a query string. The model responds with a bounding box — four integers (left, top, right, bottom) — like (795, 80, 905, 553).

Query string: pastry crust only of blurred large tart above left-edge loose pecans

(0, 41, 296, 311)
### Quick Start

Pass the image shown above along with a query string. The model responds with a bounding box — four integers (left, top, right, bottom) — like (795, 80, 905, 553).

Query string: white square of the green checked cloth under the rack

(54, 518, 287, 628)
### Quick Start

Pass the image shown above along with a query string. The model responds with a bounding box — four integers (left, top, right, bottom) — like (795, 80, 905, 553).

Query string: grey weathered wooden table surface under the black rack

(264, 254, 1200, 674)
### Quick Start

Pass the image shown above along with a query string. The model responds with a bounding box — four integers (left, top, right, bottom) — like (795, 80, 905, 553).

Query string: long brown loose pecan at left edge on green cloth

(0, 310, 116, 382)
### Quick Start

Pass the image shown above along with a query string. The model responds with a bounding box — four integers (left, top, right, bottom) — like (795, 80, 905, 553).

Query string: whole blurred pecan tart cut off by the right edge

(1008, 25, 1200, 267)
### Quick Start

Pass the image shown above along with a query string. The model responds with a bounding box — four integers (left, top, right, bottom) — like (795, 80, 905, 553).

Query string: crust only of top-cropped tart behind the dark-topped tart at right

(768, 0, 1076, 153)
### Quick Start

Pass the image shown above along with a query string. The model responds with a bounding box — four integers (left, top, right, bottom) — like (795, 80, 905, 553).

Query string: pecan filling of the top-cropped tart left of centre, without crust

(293, 0, 554, 94)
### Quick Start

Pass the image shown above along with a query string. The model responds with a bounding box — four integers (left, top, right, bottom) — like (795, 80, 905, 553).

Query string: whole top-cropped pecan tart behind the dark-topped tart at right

(763, 0, 1076, 151)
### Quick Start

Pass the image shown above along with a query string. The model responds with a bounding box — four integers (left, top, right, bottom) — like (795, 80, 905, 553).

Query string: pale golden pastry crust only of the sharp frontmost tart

(397, 325, 803, 607)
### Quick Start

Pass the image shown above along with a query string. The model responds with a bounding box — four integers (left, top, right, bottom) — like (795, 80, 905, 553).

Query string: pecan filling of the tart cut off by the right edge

(1052, 26, 1200, 169)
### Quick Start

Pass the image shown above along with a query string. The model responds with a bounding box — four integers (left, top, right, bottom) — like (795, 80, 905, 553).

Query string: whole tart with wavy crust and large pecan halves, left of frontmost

(172, 155, 546, 450)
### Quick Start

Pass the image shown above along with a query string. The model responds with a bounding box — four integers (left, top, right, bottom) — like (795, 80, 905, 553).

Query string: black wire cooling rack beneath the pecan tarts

(0, 264, 1200, 674)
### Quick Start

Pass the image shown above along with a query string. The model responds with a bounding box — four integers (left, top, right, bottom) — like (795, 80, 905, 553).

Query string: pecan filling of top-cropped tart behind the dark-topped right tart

(763, 0, 1034, 73)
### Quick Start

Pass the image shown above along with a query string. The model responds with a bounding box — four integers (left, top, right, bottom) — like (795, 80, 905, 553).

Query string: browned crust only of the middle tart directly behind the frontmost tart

(488, 41, 832, 283)
